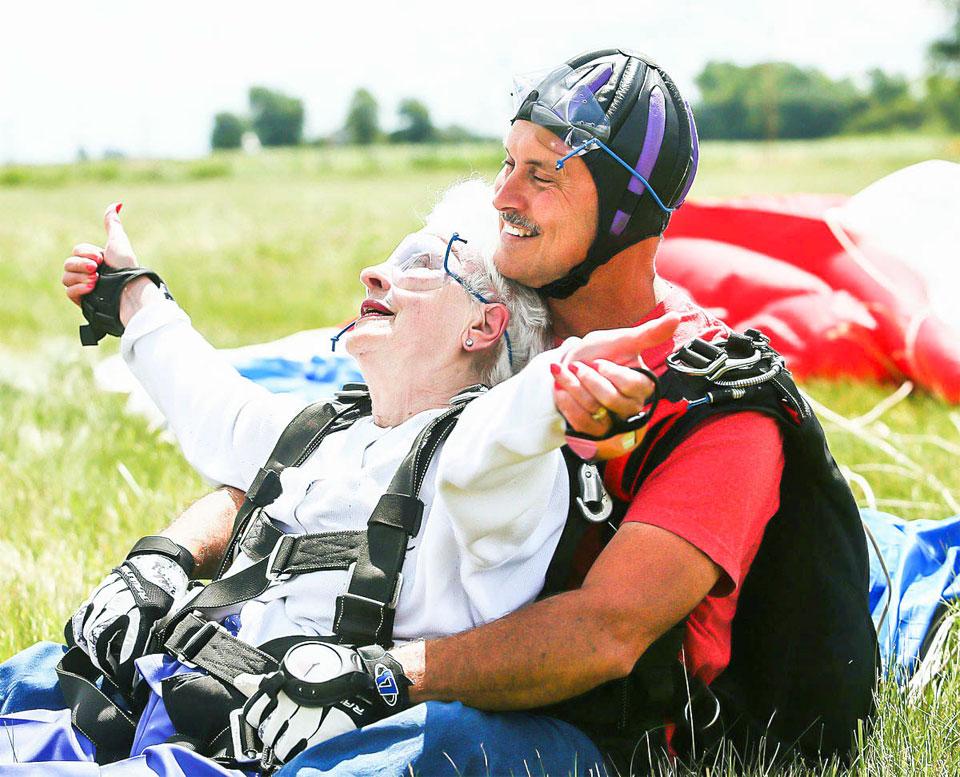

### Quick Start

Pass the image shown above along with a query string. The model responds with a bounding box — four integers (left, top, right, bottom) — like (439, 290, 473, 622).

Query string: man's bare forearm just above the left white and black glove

(161, 486, 243, 579)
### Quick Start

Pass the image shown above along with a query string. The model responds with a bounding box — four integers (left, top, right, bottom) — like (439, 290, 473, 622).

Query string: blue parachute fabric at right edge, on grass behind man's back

(861, 510, 960, 681)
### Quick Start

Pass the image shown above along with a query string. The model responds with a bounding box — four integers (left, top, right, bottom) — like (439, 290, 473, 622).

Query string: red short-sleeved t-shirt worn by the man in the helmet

(588, 289, 783, 683)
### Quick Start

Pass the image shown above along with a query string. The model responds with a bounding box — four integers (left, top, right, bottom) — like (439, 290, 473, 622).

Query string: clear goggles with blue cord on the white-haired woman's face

(330, 232, 513, 367)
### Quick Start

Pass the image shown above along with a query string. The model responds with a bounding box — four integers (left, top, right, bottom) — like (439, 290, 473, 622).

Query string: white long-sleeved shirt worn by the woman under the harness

(121, 300, 569, 644)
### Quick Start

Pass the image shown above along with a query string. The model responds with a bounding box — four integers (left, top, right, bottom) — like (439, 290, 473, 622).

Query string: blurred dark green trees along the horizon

(211, 0, 960, 149)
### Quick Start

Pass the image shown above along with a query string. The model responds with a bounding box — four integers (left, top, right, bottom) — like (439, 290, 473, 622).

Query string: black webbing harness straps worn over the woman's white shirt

(58, 384, 477, 763)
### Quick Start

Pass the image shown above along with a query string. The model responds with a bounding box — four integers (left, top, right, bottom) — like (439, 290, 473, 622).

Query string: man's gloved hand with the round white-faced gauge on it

(243, 642, 410, 763)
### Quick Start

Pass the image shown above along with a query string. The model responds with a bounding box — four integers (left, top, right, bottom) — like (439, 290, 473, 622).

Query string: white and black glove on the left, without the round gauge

(64, 537, 194, 689)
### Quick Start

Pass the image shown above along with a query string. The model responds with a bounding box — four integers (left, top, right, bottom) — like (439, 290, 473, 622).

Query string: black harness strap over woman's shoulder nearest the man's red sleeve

(333, 400, 466, 647)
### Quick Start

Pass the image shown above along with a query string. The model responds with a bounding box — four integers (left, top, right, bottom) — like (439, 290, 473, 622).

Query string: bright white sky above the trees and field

(0, 0, 949, 164)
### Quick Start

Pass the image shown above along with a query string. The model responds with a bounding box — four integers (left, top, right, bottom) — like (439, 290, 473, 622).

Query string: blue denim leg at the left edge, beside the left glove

(0, 642, 67, 714)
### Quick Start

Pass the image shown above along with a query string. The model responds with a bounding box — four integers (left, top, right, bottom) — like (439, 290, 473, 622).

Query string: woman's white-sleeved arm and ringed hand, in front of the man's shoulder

(438, 315, 678, 568)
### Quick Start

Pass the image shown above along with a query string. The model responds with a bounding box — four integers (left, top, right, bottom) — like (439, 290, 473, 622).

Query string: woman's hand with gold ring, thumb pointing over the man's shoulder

(550, 314, 680, 437)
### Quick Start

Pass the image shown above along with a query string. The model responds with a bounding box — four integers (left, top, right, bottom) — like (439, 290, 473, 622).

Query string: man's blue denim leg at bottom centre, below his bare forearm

(277, 701, 605, 777)
